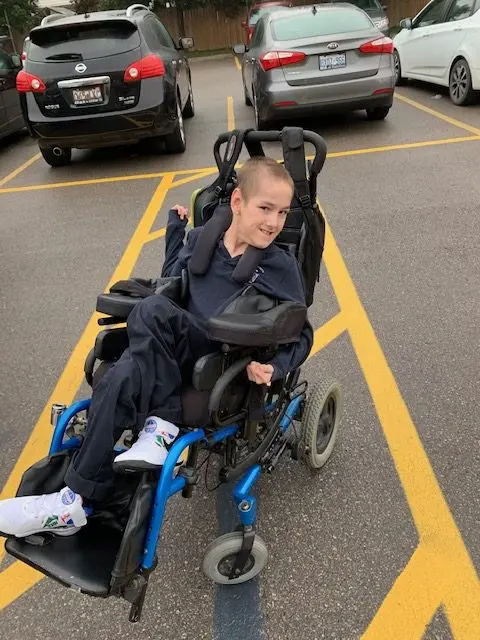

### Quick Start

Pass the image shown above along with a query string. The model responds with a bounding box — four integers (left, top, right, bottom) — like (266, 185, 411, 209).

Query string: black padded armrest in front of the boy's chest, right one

(208, 295, 307, 347)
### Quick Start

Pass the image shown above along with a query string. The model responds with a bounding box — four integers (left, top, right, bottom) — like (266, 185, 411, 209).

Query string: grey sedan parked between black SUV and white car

(234, 4, 394, 129)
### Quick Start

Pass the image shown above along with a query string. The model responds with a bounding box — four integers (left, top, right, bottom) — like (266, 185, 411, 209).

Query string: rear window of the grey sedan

(271, 9, 373, 41)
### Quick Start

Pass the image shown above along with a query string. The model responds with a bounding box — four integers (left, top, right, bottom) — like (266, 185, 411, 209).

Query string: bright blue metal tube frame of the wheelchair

(49, 394, 303, 571)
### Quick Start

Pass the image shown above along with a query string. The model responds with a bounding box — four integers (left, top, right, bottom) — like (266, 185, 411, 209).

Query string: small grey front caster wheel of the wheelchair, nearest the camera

(202, 531, 268, 584)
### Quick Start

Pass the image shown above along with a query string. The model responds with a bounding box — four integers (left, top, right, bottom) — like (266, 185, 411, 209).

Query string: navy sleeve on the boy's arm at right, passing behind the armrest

(267, 259, 313, 380)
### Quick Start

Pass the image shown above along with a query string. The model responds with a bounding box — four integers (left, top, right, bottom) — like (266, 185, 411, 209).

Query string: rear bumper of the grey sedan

(258, 65, 395, 120)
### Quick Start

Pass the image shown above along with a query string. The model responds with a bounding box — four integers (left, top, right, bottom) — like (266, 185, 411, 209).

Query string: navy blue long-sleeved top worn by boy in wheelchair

(162, 211, 313, 380)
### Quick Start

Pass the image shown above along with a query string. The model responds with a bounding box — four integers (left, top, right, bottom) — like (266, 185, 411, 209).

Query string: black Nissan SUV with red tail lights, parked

(17, 4, 194, 166)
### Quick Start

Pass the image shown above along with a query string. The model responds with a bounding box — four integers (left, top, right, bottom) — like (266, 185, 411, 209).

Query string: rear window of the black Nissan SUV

(28, 20, 140, 62)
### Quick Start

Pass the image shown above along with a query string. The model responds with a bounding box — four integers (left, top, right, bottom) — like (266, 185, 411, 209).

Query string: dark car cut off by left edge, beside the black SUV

(0, 49, 25, 138)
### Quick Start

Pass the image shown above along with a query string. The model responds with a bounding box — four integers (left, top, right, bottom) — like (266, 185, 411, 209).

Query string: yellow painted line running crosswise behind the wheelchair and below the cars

(0, 136, 480, 195)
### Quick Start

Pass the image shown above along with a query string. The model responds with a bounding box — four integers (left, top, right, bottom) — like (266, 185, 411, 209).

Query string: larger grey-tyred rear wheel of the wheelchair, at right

(299, 382, 343, 469)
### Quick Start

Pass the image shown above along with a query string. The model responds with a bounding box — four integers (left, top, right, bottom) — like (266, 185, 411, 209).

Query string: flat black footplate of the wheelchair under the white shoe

(5, 520, 122, 598)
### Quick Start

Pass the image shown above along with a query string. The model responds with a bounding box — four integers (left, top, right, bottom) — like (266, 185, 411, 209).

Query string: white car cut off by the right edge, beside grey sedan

(394, 0, 480, 106)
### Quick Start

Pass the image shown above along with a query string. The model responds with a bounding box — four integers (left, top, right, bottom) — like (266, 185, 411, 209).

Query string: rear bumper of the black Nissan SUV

(23, 87, 176, 149)
